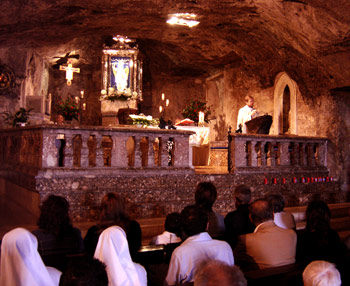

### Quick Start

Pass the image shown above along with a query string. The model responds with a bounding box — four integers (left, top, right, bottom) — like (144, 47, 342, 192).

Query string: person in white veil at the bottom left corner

(0, 228, 61, 286)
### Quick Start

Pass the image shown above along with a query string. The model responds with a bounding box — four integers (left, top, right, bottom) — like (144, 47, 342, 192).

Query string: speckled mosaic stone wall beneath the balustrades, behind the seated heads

(36, 169, 345, 222)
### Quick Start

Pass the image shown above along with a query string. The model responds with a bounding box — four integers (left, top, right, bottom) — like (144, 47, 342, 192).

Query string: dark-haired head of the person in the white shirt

(181, 205, 208, 236)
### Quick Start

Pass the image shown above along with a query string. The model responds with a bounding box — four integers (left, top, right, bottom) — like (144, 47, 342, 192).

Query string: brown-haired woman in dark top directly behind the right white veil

(84, 193, 142, 259)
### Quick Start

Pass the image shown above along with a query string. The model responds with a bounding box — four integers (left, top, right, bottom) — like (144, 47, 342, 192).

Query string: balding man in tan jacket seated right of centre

(234, 199, 297, 271)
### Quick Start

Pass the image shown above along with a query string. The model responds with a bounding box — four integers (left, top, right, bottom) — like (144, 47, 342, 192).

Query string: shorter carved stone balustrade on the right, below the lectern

(228, 134, 327, 173)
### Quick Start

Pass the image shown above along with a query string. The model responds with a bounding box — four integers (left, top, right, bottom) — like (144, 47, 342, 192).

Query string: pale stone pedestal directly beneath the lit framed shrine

(101, 99, 137, 126)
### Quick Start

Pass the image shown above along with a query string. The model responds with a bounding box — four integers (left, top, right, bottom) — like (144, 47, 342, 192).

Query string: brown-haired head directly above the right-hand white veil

(100, 193, 126, 223)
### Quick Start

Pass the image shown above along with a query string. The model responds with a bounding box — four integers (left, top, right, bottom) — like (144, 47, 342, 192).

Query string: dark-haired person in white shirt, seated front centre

(165, 205, 234, 285)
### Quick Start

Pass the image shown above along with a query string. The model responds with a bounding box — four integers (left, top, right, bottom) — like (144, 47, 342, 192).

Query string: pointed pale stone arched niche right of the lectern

(270, 72, 298, 135)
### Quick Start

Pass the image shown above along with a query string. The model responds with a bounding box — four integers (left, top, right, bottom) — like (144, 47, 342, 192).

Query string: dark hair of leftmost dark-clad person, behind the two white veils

(37, 195, 72, 237)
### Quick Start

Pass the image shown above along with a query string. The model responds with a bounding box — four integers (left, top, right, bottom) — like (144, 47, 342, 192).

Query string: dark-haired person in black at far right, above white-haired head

(296, 200, 345, 266)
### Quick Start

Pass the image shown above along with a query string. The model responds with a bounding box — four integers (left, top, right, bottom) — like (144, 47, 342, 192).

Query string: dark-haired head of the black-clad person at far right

(305, 200, 331, 231)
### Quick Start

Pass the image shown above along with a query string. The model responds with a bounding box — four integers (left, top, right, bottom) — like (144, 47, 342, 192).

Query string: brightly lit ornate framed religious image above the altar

(101, 36, 142, 101)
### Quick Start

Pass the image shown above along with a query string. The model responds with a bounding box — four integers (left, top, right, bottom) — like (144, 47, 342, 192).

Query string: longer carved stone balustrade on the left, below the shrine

(0, 125, 193, 171)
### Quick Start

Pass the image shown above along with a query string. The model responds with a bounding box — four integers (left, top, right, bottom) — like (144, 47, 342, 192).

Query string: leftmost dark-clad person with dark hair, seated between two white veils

(32, 195, 84, 271)
